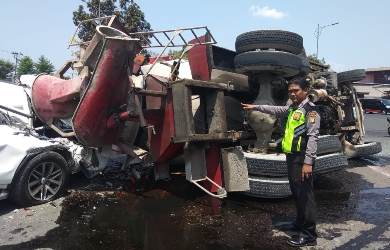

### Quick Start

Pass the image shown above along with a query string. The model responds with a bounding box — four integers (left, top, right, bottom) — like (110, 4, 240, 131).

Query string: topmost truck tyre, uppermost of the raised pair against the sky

(236, 30, 303, 54)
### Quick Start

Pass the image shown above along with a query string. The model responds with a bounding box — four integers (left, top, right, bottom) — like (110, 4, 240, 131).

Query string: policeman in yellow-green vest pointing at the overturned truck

(241, 77, 320, 247)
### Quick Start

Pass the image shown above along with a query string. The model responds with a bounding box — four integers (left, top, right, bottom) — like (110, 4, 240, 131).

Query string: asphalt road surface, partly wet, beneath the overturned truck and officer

(0, 115, 390, 250)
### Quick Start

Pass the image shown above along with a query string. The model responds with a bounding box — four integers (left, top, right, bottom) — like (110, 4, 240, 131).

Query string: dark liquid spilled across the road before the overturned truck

(0, 166, 390, 250)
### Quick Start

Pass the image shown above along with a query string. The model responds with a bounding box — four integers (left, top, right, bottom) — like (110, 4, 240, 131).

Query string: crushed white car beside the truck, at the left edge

(0, 79, 82, 205)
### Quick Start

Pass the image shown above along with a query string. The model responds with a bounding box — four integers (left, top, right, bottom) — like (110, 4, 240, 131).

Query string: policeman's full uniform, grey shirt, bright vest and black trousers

(255, 98, 320, 239)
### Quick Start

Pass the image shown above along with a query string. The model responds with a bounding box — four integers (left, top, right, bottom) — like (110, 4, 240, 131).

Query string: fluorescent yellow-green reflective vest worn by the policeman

(282, 108, 306, 154)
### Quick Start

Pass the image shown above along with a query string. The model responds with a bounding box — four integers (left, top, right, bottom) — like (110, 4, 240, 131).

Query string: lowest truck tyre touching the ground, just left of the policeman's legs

(244, 176, 291, 198)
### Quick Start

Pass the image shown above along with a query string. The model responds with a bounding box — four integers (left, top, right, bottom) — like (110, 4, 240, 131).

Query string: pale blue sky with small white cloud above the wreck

(0, 0, 390, 71)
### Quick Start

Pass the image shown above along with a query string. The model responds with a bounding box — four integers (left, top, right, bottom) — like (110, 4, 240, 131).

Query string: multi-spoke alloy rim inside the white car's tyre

(27, 162, 64, 201)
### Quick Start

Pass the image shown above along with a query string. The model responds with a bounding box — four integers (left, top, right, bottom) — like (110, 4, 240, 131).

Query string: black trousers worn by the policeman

(286, 154, 317, 238)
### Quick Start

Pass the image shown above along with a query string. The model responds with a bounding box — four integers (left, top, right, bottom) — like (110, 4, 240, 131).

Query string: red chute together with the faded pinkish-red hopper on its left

(31, 26, 139, 147)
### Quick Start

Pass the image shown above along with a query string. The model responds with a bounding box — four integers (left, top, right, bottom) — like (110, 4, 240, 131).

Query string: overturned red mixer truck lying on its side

(32, 17, 381, 198)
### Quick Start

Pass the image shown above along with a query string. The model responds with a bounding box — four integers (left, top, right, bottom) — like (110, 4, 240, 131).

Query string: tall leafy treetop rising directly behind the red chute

(73, 0, 151, 42)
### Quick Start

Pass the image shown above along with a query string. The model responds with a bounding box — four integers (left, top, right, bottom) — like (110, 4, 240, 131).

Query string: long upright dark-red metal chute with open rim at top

(72, 26, 138, 146)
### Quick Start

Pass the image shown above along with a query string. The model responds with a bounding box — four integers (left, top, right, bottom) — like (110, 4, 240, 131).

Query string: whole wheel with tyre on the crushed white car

(11, 151, 70, 206)
